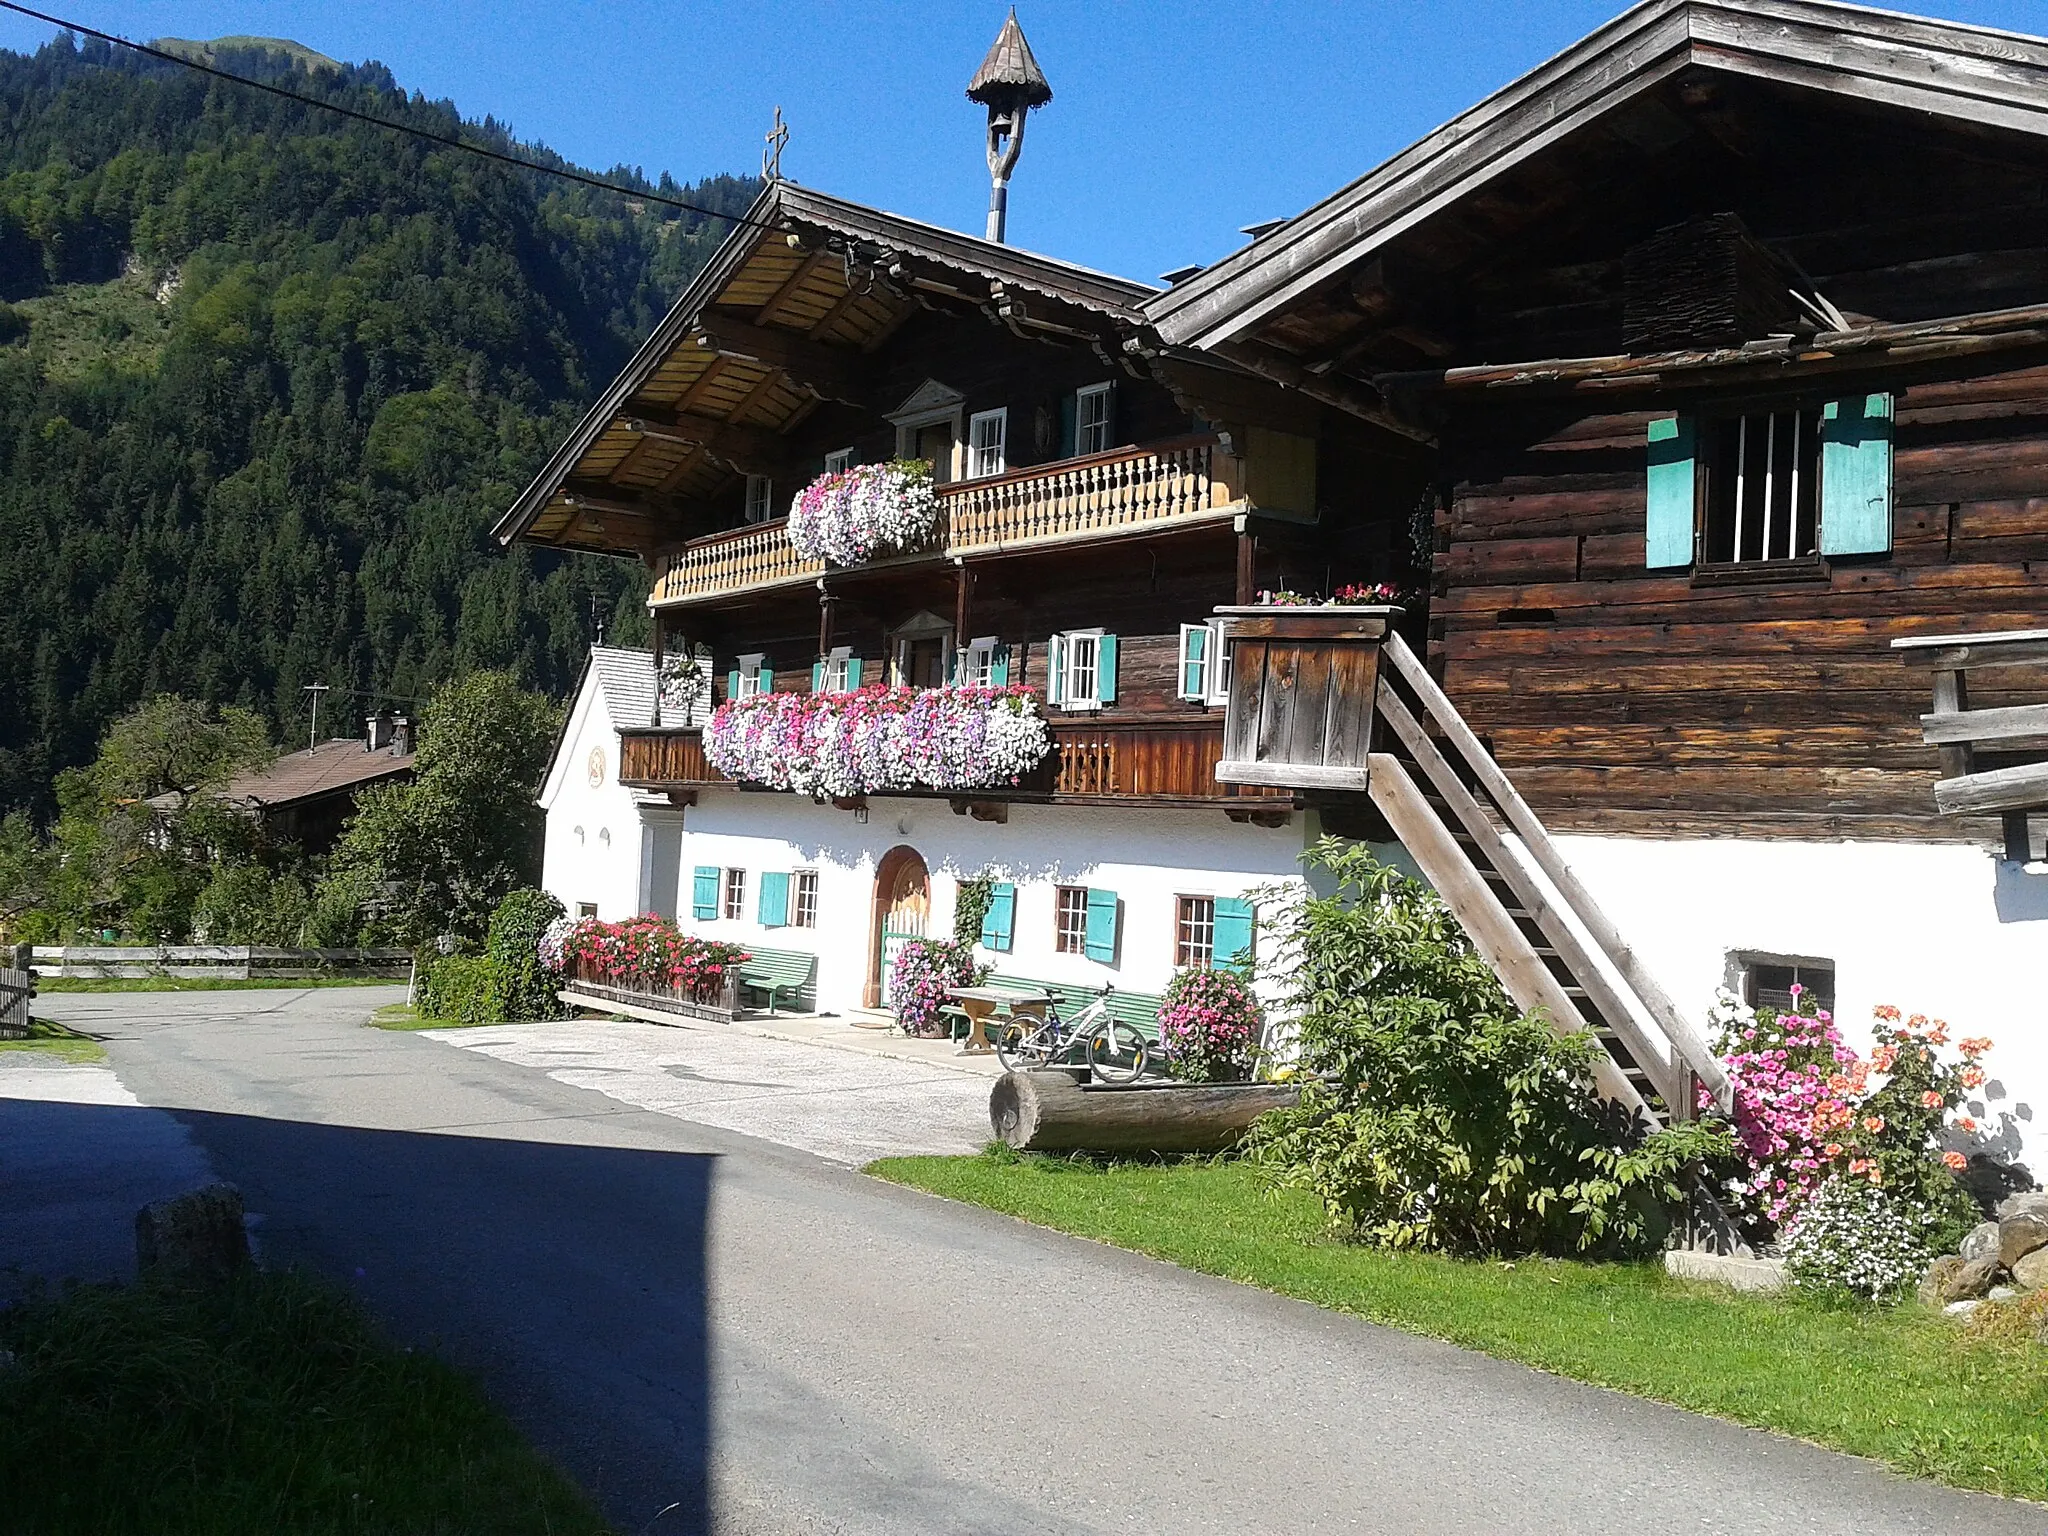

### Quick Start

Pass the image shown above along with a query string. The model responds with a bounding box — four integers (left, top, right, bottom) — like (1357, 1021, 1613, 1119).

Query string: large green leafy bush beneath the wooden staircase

(1249, 838, 1729, 1253)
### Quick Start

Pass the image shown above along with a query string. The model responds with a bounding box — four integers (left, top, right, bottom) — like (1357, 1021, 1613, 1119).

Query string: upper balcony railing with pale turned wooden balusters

(649, 436, 1245, 608)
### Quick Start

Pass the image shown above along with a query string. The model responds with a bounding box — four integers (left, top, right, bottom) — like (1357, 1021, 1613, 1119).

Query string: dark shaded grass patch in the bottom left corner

(0, 1272, 606, 1536)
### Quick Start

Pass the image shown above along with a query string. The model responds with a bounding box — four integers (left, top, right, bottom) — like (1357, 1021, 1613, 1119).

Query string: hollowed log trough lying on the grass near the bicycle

(989, 1071, 1298, 1153)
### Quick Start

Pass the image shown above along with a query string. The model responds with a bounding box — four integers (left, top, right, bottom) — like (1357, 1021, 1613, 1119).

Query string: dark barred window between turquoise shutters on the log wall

(1700, 408, 1821, 565)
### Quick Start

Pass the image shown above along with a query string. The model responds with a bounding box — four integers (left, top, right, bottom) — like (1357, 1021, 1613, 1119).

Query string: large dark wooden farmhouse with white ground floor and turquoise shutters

(498, 0, 2048, 1155)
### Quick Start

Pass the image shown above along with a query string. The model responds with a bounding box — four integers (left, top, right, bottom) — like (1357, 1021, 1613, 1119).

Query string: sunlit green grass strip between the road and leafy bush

(868, 1151, 2048, 1499)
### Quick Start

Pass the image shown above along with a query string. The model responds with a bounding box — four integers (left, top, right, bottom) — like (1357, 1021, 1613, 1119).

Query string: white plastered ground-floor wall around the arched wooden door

(680, 791, 1305, 1012)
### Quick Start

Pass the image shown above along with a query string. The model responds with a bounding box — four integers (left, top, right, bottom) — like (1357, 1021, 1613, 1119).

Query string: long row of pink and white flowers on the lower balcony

(705, 684, 1053, 799)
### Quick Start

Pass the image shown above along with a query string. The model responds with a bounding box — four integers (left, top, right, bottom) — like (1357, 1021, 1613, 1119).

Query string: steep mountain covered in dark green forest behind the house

(0, 39, 756, 809)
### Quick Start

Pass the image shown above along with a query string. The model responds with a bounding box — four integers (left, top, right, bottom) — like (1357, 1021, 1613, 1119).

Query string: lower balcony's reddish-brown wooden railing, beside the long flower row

(618, 719, 1292, 811)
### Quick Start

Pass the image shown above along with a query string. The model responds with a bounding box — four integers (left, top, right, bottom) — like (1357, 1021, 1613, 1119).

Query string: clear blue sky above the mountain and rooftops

(0, 0, 2048, 279)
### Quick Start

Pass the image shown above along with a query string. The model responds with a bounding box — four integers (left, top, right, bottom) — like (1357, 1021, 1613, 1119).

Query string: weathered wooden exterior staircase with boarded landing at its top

(1217, 608, 1731, 1124)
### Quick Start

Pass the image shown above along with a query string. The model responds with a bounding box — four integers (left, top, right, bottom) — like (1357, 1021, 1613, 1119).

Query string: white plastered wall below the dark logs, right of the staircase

(1556, 836, 2048, 1174)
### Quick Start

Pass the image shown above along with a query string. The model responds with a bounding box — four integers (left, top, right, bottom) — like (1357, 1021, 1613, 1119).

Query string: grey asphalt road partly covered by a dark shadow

(16, 991, 2048, 1536)
